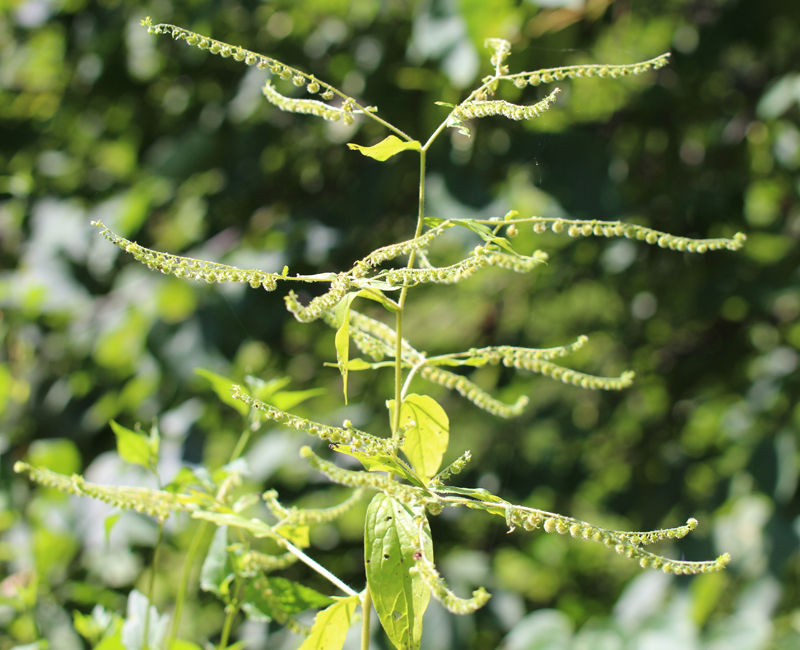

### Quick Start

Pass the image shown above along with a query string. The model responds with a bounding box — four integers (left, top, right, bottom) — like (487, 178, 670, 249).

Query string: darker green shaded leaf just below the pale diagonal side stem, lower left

(244, 576, 333, 623)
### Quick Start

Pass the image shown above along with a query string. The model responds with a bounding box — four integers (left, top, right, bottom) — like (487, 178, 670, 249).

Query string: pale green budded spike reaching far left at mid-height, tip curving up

(92, 221, 281, 291)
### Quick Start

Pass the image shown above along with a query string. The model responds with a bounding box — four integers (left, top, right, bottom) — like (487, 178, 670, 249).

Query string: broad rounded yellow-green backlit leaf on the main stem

(389, 393, 450, 483)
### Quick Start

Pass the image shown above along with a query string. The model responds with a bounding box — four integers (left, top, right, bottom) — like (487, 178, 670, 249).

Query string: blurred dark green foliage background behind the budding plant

(0, 0, 800, 650)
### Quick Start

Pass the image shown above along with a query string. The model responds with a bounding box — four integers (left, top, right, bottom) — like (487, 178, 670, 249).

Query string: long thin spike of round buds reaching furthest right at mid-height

(533, 219, 747, 253)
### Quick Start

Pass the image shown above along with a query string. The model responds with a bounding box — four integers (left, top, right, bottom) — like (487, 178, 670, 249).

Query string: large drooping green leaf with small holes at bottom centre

(364, 494, 433, 650)
